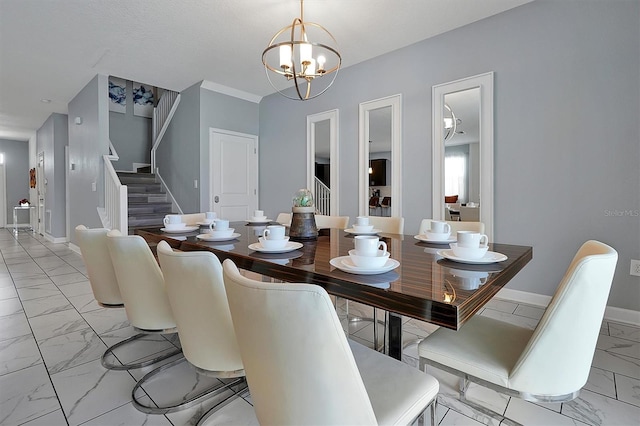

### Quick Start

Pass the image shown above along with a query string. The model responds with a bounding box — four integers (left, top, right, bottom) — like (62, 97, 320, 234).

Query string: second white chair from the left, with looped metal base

(102, 230, 182, 370)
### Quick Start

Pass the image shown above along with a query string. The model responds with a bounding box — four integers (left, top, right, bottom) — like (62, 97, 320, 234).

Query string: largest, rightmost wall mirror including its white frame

(432, 72, 493, 241)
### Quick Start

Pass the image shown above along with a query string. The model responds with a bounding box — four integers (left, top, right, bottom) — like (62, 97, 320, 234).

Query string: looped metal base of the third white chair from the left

(131, 357, 246, 414)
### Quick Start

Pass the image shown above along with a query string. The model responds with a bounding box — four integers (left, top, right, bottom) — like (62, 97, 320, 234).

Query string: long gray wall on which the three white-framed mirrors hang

(260, 0, 640, 311)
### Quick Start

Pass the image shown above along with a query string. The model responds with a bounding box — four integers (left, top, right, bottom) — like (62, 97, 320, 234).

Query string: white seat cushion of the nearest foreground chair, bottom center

(349, 340, 439, 425)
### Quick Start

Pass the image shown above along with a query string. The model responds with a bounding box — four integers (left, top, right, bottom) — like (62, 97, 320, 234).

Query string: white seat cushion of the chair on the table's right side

(418, 315, 533, 388)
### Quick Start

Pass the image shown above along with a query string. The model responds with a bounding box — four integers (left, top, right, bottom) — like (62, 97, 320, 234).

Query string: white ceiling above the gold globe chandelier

(0, 0, 531, 140)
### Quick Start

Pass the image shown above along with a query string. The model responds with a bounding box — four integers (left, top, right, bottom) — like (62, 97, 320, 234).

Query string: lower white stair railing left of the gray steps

(102, 155, 129, 235)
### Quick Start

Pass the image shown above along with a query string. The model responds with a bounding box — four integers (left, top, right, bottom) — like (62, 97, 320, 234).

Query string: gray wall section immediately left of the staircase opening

(68, 74, 109, 240)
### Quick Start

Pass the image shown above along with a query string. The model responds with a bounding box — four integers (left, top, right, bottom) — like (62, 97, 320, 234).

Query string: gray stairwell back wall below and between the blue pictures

(109, 80, 152, 171)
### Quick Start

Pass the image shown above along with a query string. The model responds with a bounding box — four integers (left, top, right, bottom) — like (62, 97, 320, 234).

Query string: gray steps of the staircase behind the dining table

(117, 172, 171, 234)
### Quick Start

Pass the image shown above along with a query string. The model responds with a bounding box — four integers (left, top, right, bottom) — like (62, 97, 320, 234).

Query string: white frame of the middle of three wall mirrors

(358, 94, 402, 217)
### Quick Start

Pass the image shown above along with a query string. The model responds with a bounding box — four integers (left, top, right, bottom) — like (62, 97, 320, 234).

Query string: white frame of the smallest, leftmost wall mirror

(307, 109, 340, 215)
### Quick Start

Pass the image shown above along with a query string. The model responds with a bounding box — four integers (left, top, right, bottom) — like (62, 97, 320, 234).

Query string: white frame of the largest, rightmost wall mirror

(431, 72, 494, 241)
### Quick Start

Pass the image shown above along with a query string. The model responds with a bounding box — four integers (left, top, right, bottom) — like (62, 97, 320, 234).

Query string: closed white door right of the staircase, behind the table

(209, 129, 258, 221)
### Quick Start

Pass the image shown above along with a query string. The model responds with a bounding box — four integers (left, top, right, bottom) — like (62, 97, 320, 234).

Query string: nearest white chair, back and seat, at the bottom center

(223, 259, 439, 425)
